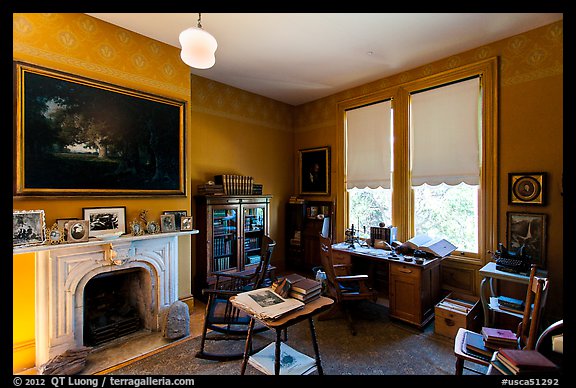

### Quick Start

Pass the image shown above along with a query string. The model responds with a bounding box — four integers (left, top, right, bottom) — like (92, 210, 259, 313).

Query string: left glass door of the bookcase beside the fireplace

(209, 207, 238, 272)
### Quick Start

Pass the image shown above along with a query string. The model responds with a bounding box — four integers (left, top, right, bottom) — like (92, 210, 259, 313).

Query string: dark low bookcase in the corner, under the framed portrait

(286, 200, 334, 274)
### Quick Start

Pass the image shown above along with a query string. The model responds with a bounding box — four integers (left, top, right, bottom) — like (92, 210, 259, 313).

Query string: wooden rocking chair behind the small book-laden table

(196, 236, 276, 361)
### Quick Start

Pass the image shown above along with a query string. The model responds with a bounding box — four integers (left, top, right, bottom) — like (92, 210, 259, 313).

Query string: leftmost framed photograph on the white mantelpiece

(12, 210, 46, 246)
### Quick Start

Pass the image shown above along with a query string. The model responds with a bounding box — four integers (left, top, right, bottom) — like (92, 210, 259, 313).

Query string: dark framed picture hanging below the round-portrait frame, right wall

(506, 212, 546, 268)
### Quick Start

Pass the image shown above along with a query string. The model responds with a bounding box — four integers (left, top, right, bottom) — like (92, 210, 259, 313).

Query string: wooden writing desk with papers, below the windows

(332, 242, 442, 329)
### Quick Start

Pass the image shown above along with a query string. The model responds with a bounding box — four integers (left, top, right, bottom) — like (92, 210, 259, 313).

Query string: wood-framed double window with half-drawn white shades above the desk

(339, 58, 497, 263)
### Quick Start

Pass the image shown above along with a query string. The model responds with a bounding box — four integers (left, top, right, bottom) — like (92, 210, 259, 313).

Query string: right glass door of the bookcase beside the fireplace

(243, 205, 266, 266)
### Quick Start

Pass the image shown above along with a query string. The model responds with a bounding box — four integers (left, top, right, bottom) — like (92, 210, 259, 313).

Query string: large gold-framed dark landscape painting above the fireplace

(13, 62, 186, 196)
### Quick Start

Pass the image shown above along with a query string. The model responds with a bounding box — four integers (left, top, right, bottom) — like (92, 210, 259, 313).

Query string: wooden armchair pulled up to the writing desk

(320, 234, 378, 335)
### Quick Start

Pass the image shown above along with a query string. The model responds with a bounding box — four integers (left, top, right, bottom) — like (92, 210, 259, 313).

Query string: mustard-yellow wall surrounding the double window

(294, 21, 563, 317)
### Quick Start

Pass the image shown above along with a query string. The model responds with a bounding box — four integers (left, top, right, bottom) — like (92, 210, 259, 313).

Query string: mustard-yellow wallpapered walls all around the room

(13, 14, 563, 370)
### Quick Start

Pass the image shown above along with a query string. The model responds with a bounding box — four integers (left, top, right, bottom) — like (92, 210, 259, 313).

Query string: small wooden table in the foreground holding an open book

(230, 296, 334, 375)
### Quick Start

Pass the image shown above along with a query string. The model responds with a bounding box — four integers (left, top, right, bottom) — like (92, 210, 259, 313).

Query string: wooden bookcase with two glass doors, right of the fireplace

(193, 195, 272, 299)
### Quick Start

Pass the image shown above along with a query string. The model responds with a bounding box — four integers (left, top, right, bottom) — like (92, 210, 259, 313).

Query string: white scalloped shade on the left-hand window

(346, 100, 392, 189)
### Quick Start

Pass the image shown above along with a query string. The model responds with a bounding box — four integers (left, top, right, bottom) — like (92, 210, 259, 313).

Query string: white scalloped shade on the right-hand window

(410, 78, 480, 186)
